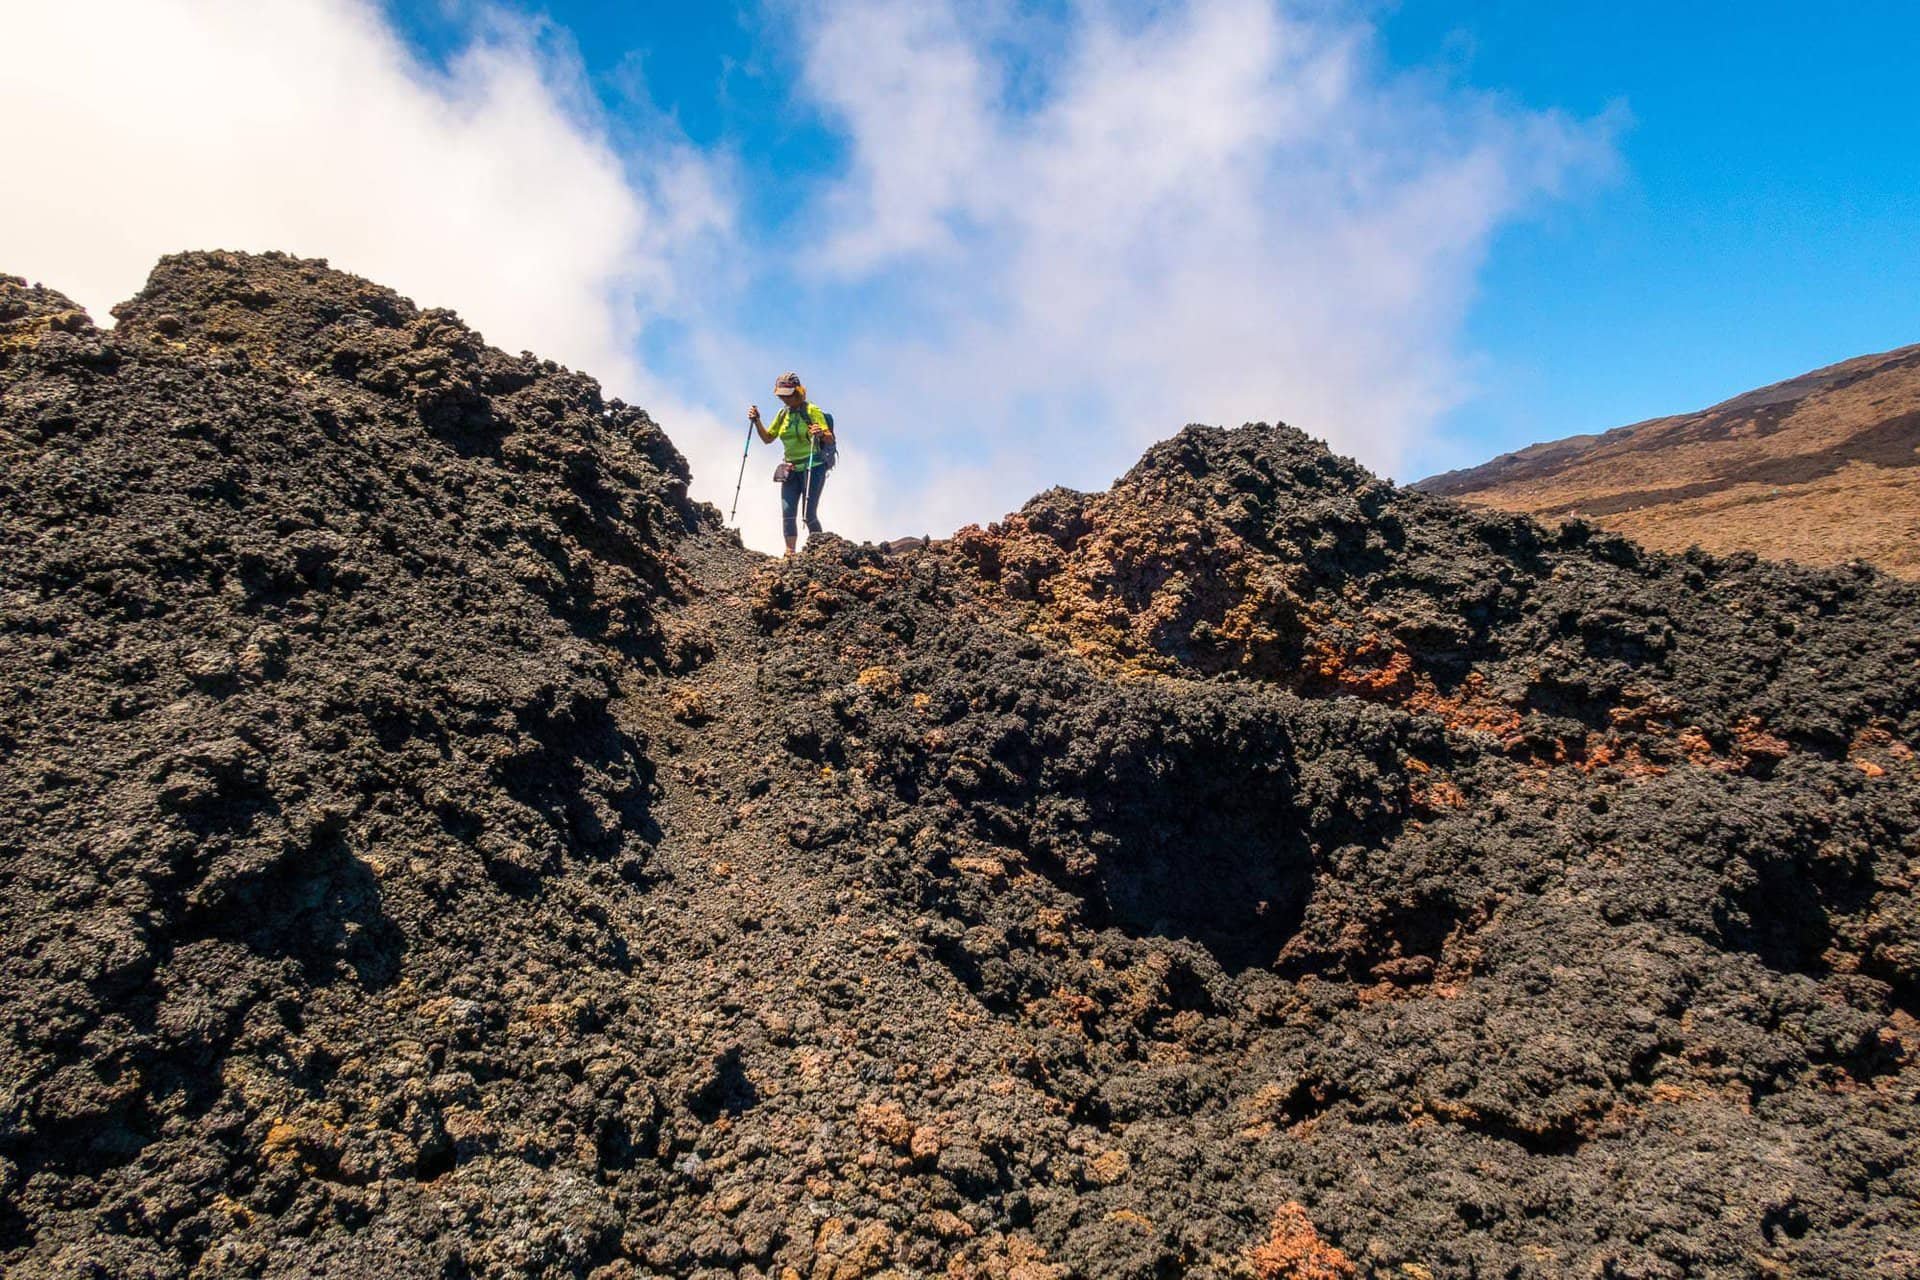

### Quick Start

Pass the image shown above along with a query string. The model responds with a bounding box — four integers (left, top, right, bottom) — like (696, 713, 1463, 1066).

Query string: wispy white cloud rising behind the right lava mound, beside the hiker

(779, 0, 1613, 532)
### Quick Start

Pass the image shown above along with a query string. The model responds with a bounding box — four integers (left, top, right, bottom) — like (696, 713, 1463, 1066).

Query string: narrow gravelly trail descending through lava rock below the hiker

(599, 537, 1113, 1278)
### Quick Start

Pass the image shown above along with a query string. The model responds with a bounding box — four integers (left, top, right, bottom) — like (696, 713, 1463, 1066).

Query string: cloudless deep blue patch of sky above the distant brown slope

(1380, 0, 1920, 470)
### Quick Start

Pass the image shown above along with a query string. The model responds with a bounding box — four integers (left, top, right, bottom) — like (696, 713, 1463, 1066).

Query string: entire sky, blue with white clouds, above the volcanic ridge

(0, 0, 1920, 549)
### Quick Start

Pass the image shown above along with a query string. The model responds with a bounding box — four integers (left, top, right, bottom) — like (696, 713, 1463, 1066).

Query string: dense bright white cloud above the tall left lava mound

(0, 0, 730, 410)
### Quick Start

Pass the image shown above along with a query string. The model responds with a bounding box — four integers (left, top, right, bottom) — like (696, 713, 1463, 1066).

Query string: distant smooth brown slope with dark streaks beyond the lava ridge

(1413, 345, 1920, 578)
